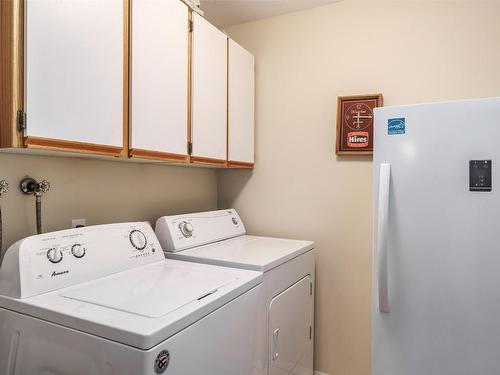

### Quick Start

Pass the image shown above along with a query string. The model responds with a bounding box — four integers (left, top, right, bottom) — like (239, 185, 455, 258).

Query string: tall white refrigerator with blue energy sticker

(372, 98, 500, 375)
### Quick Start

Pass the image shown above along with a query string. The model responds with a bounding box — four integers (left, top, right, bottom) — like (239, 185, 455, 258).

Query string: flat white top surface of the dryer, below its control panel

(170, 235, 314, 272)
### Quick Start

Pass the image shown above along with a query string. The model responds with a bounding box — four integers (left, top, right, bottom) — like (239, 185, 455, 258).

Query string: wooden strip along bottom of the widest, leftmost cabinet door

(24, 137, 123, 157)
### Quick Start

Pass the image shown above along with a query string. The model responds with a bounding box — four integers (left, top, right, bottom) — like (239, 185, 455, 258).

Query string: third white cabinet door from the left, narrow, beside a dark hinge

(192, 13, 227, 163)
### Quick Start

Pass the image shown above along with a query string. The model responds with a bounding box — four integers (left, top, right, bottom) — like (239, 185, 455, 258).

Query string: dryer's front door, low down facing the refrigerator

(268, 275, 313, 375)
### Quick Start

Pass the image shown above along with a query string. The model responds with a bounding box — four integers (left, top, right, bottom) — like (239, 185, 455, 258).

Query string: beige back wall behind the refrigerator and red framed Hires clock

(219, 1, 500, 375)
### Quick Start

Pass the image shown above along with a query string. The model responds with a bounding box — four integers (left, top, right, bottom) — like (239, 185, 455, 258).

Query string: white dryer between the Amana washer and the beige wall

(155, 209, 314, 375)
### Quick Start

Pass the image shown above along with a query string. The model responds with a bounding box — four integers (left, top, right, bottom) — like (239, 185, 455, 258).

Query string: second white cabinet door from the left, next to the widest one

(130, 0, 189, 159)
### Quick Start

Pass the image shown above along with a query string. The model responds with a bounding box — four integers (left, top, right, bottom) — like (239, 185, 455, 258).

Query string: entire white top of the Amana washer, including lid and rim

(0, 259, 263, 350)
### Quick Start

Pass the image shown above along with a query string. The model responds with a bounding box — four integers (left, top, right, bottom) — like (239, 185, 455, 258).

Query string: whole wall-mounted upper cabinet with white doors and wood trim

(0, 0, 254, 168)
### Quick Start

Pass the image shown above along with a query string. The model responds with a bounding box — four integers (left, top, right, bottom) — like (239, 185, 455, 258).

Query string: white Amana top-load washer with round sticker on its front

(0, 223, 263, 375)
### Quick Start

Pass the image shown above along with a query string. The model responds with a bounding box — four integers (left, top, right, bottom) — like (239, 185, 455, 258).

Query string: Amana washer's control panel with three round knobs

(0, 222, 165, 298)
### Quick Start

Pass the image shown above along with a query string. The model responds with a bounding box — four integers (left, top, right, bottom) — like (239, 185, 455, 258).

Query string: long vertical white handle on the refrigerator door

(376, 163, 391, 313)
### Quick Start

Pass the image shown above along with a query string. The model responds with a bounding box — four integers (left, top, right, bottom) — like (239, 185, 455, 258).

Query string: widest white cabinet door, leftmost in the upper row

(24, 0, 126, 149)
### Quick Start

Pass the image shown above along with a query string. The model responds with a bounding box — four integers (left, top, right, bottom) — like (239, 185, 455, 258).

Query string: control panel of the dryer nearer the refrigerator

(155, 209, 246, 252)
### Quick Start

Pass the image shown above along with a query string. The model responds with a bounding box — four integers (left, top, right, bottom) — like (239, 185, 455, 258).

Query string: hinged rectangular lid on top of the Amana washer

(61, 262, 237, 318)
